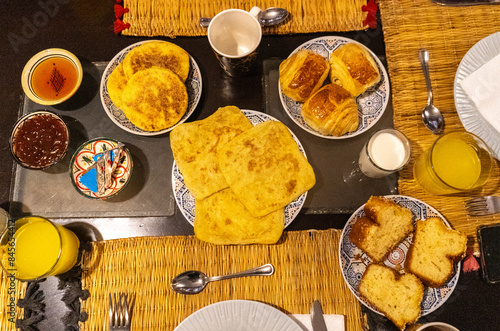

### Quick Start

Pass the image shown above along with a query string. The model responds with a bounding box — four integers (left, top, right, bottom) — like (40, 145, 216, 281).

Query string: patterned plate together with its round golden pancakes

(100, 40, 202, 136)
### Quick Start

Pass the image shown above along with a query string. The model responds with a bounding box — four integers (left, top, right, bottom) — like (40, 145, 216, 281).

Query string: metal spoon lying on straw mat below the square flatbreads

(170, 264, 274, 294)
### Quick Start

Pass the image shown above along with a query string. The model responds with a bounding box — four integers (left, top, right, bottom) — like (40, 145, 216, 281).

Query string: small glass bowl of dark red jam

(10, 110, 69, 169)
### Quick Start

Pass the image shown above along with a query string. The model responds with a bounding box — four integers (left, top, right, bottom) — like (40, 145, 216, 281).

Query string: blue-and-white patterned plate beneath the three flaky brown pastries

(278, 36, 390, 139)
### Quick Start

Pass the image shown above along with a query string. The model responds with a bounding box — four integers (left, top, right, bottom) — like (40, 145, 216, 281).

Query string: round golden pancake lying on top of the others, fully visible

(120, 67, 188, 131)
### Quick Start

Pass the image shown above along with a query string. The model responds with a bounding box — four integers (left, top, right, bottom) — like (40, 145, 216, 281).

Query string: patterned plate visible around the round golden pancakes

(99, 40, 202, 136)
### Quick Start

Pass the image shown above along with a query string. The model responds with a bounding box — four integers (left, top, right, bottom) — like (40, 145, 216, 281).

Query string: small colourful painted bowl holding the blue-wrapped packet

(70, 138, 133, 199)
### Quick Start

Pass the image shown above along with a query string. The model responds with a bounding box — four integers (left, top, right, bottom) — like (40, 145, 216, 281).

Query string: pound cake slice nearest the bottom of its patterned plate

(359, 263, 424, 330)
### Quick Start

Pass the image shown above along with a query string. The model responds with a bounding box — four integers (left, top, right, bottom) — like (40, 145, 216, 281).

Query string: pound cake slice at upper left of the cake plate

(349, 196, 414, 262)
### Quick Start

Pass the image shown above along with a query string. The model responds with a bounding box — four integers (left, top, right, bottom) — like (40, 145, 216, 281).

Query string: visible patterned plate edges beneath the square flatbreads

(171, 109, 309, 228)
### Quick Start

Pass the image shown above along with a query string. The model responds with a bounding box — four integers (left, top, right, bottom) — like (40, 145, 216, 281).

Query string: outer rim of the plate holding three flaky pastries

(278, 35, 391, 140)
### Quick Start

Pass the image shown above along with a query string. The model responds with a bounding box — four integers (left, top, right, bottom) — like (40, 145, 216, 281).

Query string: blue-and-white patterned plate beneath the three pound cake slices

(339, 195, 460, 316)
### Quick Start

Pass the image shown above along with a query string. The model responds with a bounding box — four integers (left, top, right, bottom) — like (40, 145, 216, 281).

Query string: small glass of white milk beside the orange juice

(358, 129, 411, 178)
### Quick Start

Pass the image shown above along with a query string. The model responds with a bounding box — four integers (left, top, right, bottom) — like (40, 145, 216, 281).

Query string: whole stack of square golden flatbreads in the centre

(170, 106, 316, 245)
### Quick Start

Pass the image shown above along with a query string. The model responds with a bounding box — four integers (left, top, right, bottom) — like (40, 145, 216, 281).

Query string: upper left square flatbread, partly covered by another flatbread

(170, 106, 252, 199)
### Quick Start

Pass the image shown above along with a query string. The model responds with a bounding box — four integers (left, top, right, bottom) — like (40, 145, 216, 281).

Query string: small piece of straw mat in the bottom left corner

(0, 269, 27, 331)
